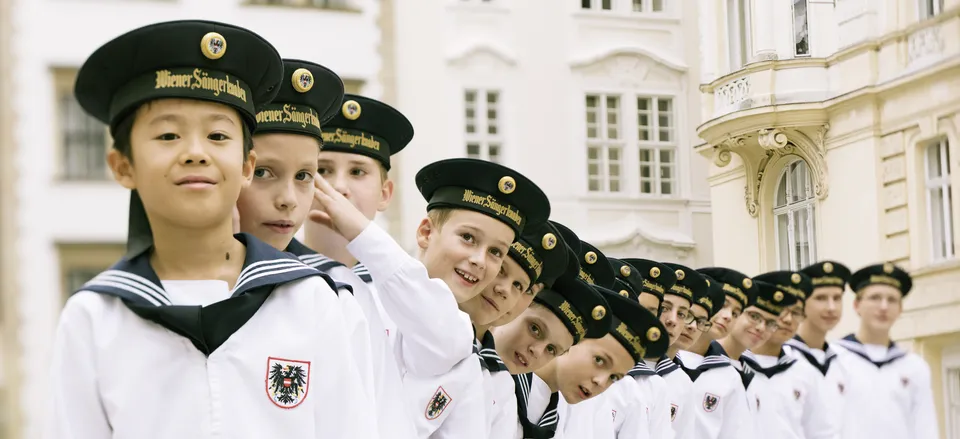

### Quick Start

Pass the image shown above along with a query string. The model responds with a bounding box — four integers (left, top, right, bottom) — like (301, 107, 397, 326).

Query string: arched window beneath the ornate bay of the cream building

(773, 160, 817, 270)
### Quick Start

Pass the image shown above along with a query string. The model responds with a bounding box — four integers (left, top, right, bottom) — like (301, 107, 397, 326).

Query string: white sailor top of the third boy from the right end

(741, 349, 839, 439)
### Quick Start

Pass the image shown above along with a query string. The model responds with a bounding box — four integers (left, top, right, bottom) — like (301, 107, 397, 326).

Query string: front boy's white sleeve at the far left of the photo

(43, 292, 113, 439)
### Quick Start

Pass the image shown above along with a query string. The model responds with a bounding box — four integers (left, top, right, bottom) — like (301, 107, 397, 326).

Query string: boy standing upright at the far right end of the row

(834, 263, 940, 439)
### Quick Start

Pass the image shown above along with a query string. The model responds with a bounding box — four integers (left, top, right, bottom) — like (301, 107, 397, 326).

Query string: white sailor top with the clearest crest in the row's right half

(677, 342, 753, 439)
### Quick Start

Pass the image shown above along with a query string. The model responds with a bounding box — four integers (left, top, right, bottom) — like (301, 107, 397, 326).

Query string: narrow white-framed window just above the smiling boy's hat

(463, 87, 504, 164)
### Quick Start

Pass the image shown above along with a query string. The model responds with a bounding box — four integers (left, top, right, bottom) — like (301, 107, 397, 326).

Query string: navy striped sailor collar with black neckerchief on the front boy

(80, 233, 336, 356)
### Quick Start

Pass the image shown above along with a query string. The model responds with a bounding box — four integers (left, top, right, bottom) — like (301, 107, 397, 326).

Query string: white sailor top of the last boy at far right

(834, 334, 940, 439)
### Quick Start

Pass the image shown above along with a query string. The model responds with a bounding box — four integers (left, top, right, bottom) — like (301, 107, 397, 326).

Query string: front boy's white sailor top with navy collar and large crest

(45, 234, 378, 439)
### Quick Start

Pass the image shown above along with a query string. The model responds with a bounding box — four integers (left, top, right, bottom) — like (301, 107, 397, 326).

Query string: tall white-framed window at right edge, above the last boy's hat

(923, 137, 955, 262)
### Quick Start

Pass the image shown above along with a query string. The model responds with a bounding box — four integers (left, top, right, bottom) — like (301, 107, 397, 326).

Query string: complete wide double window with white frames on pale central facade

(581, 90, 683, 199)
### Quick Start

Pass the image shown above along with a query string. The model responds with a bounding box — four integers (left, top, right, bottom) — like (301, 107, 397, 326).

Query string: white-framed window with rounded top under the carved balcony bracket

(772, 159, 817, 270)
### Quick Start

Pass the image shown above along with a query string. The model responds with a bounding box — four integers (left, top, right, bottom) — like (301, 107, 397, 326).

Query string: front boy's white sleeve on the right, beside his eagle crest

(310, 279, 379, 439)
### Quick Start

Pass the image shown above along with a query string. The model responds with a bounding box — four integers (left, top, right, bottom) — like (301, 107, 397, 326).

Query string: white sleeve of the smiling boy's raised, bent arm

(347, 222, 474, 376)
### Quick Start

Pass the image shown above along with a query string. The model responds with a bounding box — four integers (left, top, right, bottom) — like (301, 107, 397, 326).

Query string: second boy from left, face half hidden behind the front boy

(237, 59, 379, 406)
